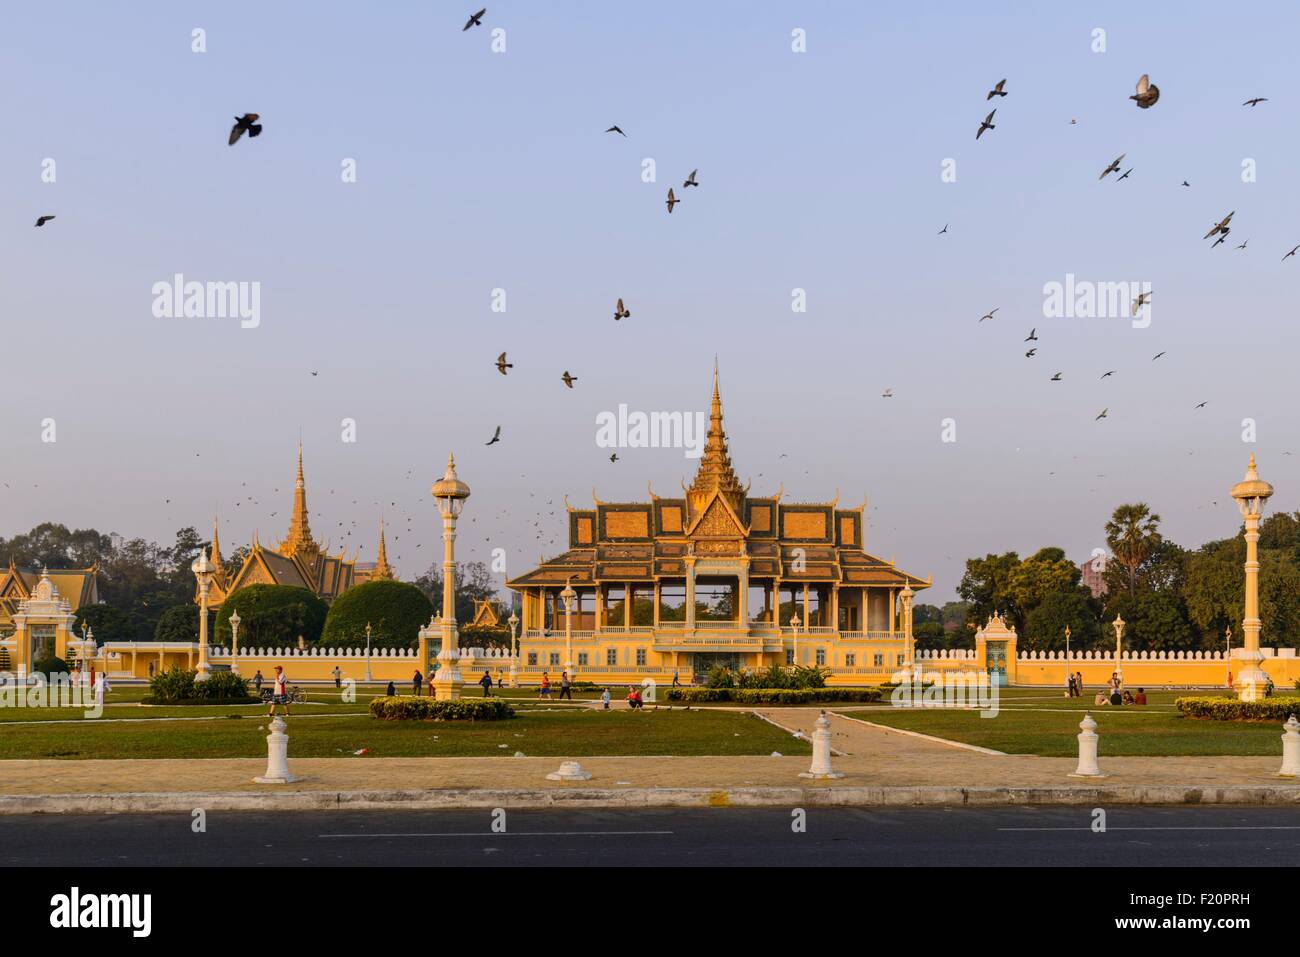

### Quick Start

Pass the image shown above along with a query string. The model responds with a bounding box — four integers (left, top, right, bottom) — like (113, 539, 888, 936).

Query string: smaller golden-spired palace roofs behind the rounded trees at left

(202, 446, 395, 609)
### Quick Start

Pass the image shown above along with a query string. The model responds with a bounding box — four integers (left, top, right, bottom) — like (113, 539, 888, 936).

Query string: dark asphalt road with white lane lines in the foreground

(0, 806, 1300, 867)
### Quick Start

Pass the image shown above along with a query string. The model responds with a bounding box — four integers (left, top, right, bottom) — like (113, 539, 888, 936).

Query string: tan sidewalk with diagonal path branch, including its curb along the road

(0, 709, 1300, 813)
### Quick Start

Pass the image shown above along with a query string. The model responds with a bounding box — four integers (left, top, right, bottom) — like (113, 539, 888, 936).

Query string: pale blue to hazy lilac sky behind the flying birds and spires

(0, 0, 1300, 601)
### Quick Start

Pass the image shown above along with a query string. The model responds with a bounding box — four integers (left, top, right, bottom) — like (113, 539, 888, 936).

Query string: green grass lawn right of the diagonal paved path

(835, 689, 1300, 759)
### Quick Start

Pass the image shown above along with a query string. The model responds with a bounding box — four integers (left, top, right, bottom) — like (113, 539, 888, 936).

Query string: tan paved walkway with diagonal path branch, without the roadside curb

(0, 709, 1300, 796)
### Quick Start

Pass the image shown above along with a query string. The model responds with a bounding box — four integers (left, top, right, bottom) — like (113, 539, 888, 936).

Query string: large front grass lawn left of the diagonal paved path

(0, 707, 811, 761)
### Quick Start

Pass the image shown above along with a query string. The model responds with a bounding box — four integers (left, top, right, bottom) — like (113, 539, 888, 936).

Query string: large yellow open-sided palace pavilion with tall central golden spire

(506, 367, 930, 684)
